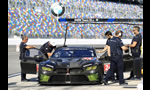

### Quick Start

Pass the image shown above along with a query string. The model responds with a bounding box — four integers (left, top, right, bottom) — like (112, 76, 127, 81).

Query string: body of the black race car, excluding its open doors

(38, 47, 104, 84)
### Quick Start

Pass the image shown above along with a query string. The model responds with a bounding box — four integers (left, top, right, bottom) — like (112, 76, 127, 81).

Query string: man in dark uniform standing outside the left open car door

(19, 36, 35, 81)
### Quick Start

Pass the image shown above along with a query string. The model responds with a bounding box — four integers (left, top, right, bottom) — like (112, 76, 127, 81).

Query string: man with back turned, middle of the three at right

(103, 30, 128, 85)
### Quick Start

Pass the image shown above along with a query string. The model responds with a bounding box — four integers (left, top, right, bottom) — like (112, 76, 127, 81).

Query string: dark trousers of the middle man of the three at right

(104, 56, 124, 84)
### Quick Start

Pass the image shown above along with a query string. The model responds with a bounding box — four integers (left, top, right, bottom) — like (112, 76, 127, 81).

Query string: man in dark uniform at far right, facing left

(127, 26, 142, 80)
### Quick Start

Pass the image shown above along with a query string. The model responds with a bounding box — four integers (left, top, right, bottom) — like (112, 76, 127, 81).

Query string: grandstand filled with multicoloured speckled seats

(8, 0, 143, 39)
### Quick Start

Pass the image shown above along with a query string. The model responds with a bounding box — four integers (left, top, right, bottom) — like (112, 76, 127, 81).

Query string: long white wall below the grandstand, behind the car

(8, 38, 131, 45)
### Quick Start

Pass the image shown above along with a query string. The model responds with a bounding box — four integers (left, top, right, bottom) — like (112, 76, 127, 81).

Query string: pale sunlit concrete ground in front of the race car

(8, 72, 142, 90)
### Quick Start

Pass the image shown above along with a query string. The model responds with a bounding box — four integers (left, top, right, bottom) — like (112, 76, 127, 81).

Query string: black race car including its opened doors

(21, 47, 142, 84)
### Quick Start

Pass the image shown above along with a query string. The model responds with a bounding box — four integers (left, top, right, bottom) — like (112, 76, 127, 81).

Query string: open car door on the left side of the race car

(21, 48, 47, 74)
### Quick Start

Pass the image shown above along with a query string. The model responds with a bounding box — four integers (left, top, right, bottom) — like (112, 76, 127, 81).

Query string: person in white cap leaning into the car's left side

(40, 41, 56, 58)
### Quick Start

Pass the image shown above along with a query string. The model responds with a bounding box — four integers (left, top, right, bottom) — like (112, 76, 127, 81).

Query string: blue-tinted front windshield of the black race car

(52, 50, 95, 58)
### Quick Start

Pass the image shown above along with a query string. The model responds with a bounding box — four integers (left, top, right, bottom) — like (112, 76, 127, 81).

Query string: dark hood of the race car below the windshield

(42, 57, 99, 68)
